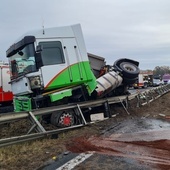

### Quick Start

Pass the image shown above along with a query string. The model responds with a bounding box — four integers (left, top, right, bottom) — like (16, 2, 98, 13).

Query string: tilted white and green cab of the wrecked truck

(6, 24, 96, 111)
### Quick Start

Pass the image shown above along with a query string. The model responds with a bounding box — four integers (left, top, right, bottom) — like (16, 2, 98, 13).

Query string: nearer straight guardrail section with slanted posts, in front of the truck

(0, 95, 127, 147)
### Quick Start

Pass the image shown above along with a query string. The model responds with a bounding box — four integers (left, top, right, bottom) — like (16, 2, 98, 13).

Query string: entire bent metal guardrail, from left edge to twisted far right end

(0, 85, 170, 147)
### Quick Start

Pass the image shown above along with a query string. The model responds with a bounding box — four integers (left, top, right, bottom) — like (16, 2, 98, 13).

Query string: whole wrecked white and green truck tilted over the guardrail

(6, 24, 139, 126)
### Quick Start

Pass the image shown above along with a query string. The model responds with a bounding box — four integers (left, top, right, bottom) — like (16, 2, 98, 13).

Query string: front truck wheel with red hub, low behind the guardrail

(51, 110, 75, 127)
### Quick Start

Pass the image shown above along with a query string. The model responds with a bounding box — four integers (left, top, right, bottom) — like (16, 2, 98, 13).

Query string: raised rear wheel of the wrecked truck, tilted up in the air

(120, 62, 140, 78)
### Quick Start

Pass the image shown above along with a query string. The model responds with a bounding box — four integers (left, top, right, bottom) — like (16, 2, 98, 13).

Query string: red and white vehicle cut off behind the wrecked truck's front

(0, 61, 13, 108)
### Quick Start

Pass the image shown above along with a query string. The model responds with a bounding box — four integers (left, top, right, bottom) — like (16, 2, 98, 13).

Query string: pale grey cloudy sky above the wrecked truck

(0, 0, 170, 70)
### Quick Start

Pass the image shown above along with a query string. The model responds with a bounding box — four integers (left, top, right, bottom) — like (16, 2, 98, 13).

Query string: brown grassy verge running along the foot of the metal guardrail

(0, 93, 170, 170)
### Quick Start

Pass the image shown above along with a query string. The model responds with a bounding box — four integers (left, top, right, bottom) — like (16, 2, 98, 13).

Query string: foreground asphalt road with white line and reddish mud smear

(43, 118, 170, 170)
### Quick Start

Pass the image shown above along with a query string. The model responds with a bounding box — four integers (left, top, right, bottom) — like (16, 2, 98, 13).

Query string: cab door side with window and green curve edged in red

(38, 38, 83, 90)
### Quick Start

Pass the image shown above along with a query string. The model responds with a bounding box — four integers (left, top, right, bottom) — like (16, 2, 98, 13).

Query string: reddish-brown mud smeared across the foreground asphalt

(67, 130, 170, 170)
